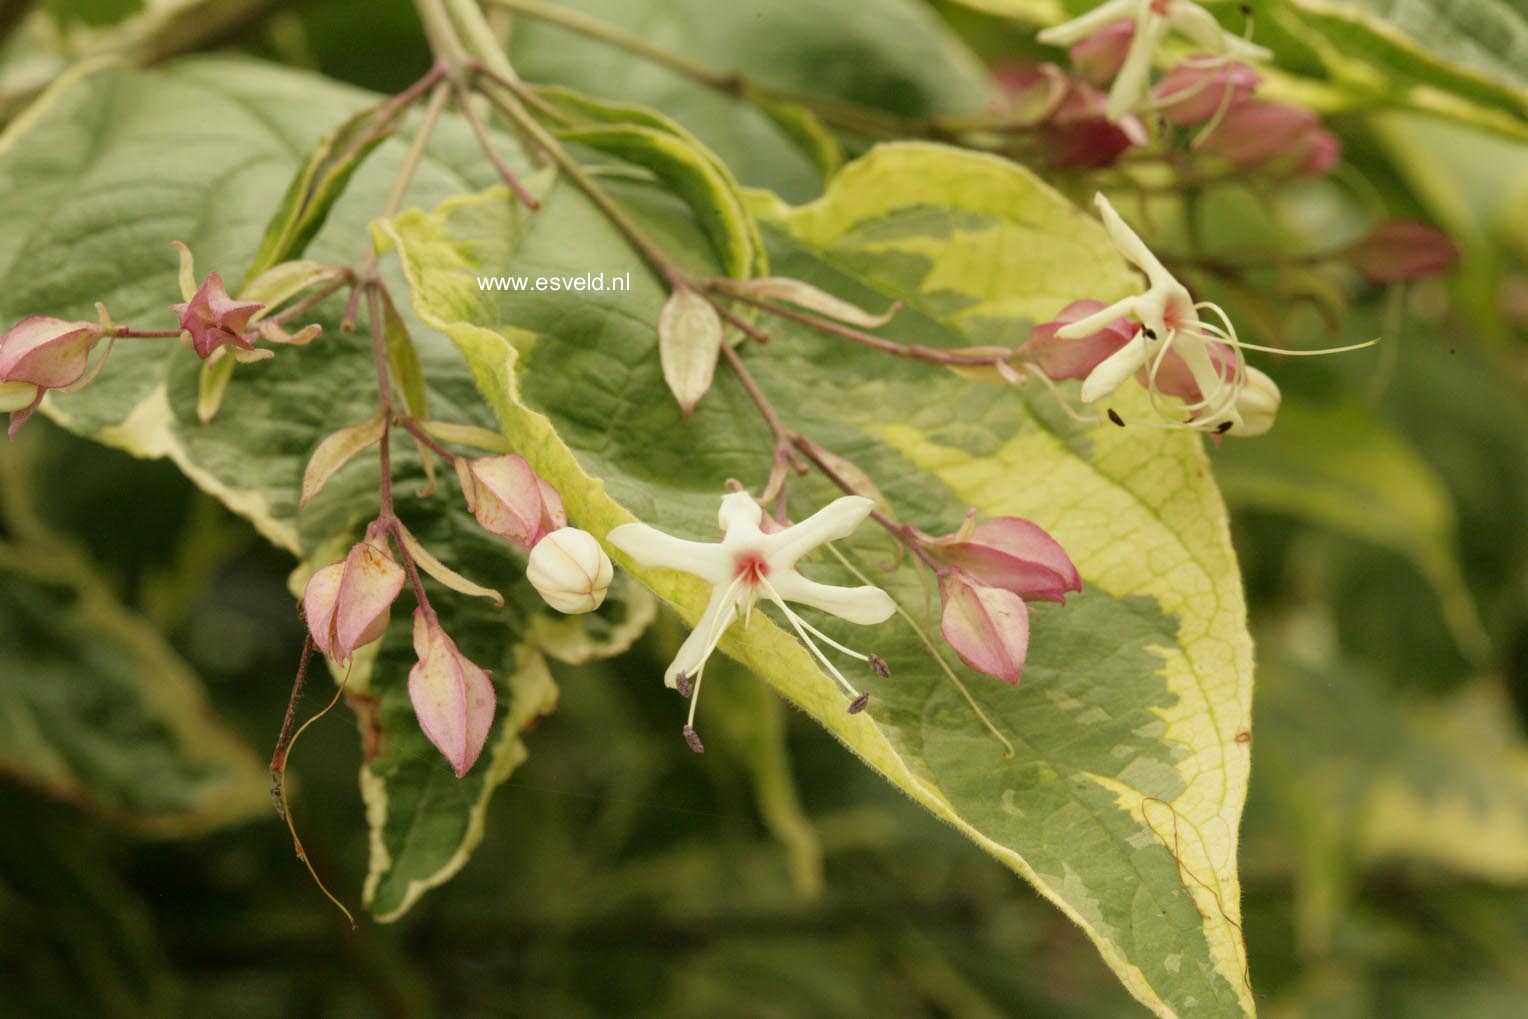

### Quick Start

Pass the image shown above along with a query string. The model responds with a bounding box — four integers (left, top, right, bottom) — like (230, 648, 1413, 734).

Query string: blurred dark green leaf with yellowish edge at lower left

(0, 451, 270, 837)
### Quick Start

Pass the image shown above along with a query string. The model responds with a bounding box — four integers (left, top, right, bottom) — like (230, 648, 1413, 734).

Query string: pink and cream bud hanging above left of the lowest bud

(303, 535, 405, 662)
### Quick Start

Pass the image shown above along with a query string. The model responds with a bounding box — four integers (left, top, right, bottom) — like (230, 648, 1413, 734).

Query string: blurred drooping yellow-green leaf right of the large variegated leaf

(1212, 400, 1490, 657)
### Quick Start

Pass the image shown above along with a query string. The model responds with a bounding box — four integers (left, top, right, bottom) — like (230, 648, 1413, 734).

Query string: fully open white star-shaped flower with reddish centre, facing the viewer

(608, 492, 897, 750)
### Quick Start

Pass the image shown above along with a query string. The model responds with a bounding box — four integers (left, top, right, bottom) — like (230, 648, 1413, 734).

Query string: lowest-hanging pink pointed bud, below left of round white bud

(408, 608, 497, 778)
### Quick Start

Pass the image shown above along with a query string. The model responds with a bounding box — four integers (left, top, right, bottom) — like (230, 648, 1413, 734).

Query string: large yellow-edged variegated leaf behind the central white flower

(384, 145, 1253, 1016)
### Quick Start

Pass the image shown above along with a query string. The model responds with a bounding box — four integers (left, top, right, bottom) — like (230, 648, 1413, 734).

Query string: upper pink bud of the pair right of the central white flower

(929, 516, 1082, 602)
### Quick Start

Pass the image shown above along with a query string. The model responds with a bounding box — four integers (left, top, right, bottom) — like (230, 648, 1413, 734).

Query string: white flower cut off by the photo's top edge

(1038, 0, 1273, 121)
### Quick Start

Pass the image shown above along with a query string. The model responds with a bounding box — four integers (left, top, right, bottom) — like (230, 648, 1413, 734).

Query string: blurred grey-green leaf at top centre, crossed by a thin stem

(512, 0, 993, 200)
